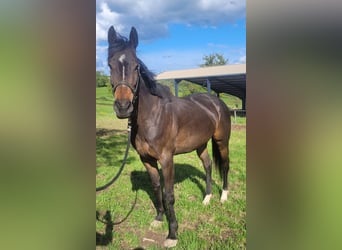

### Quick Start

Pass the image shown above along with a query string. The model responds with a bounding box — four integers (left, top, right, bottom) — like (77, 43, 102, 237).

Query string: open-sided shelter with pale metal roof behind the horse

(156, 64, 246, 110)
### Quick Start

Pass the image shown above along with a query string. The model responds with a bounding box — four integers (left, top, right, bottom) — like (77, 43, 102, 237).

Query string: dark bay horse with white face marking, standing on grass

(108, 26, 231, 247)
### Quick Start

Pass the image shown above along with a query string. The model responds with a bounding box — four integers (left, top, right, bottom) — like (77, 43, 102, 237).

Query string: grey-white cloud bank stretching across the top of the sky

(96, 0, 246, 41)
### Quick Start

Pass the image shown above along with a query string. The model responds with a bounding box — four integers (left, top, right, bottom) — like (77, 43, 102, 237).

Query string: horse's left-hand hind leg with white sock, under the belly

(197, 144, 212, 205)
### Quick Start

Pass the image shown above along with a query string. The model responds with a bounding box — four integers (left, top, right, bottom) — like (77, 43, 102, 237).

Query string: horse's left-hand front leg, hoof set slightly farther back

(140, 157, 165, 227)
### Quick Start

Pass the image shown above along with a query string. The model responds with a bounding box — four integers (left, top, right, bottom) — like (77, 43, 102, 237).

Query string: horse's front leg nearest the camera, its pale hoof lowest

(160, 155, 178, 247)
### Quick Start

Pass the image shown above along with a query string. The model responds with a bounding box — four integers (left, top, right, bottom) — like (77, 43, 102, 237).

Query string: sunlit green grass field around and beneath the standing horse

(96, 88, 246, 250)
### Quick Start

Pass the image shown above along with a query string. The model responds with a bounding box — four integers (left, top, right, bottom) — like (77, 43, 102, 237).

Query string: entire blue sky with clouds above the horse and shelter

(96, 0, 246, 74)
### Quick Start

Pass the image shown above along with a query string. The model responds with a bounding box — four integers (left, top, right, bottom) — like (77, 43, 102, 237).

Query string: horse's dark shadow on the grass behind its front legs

(131, 164, 215, 206)
